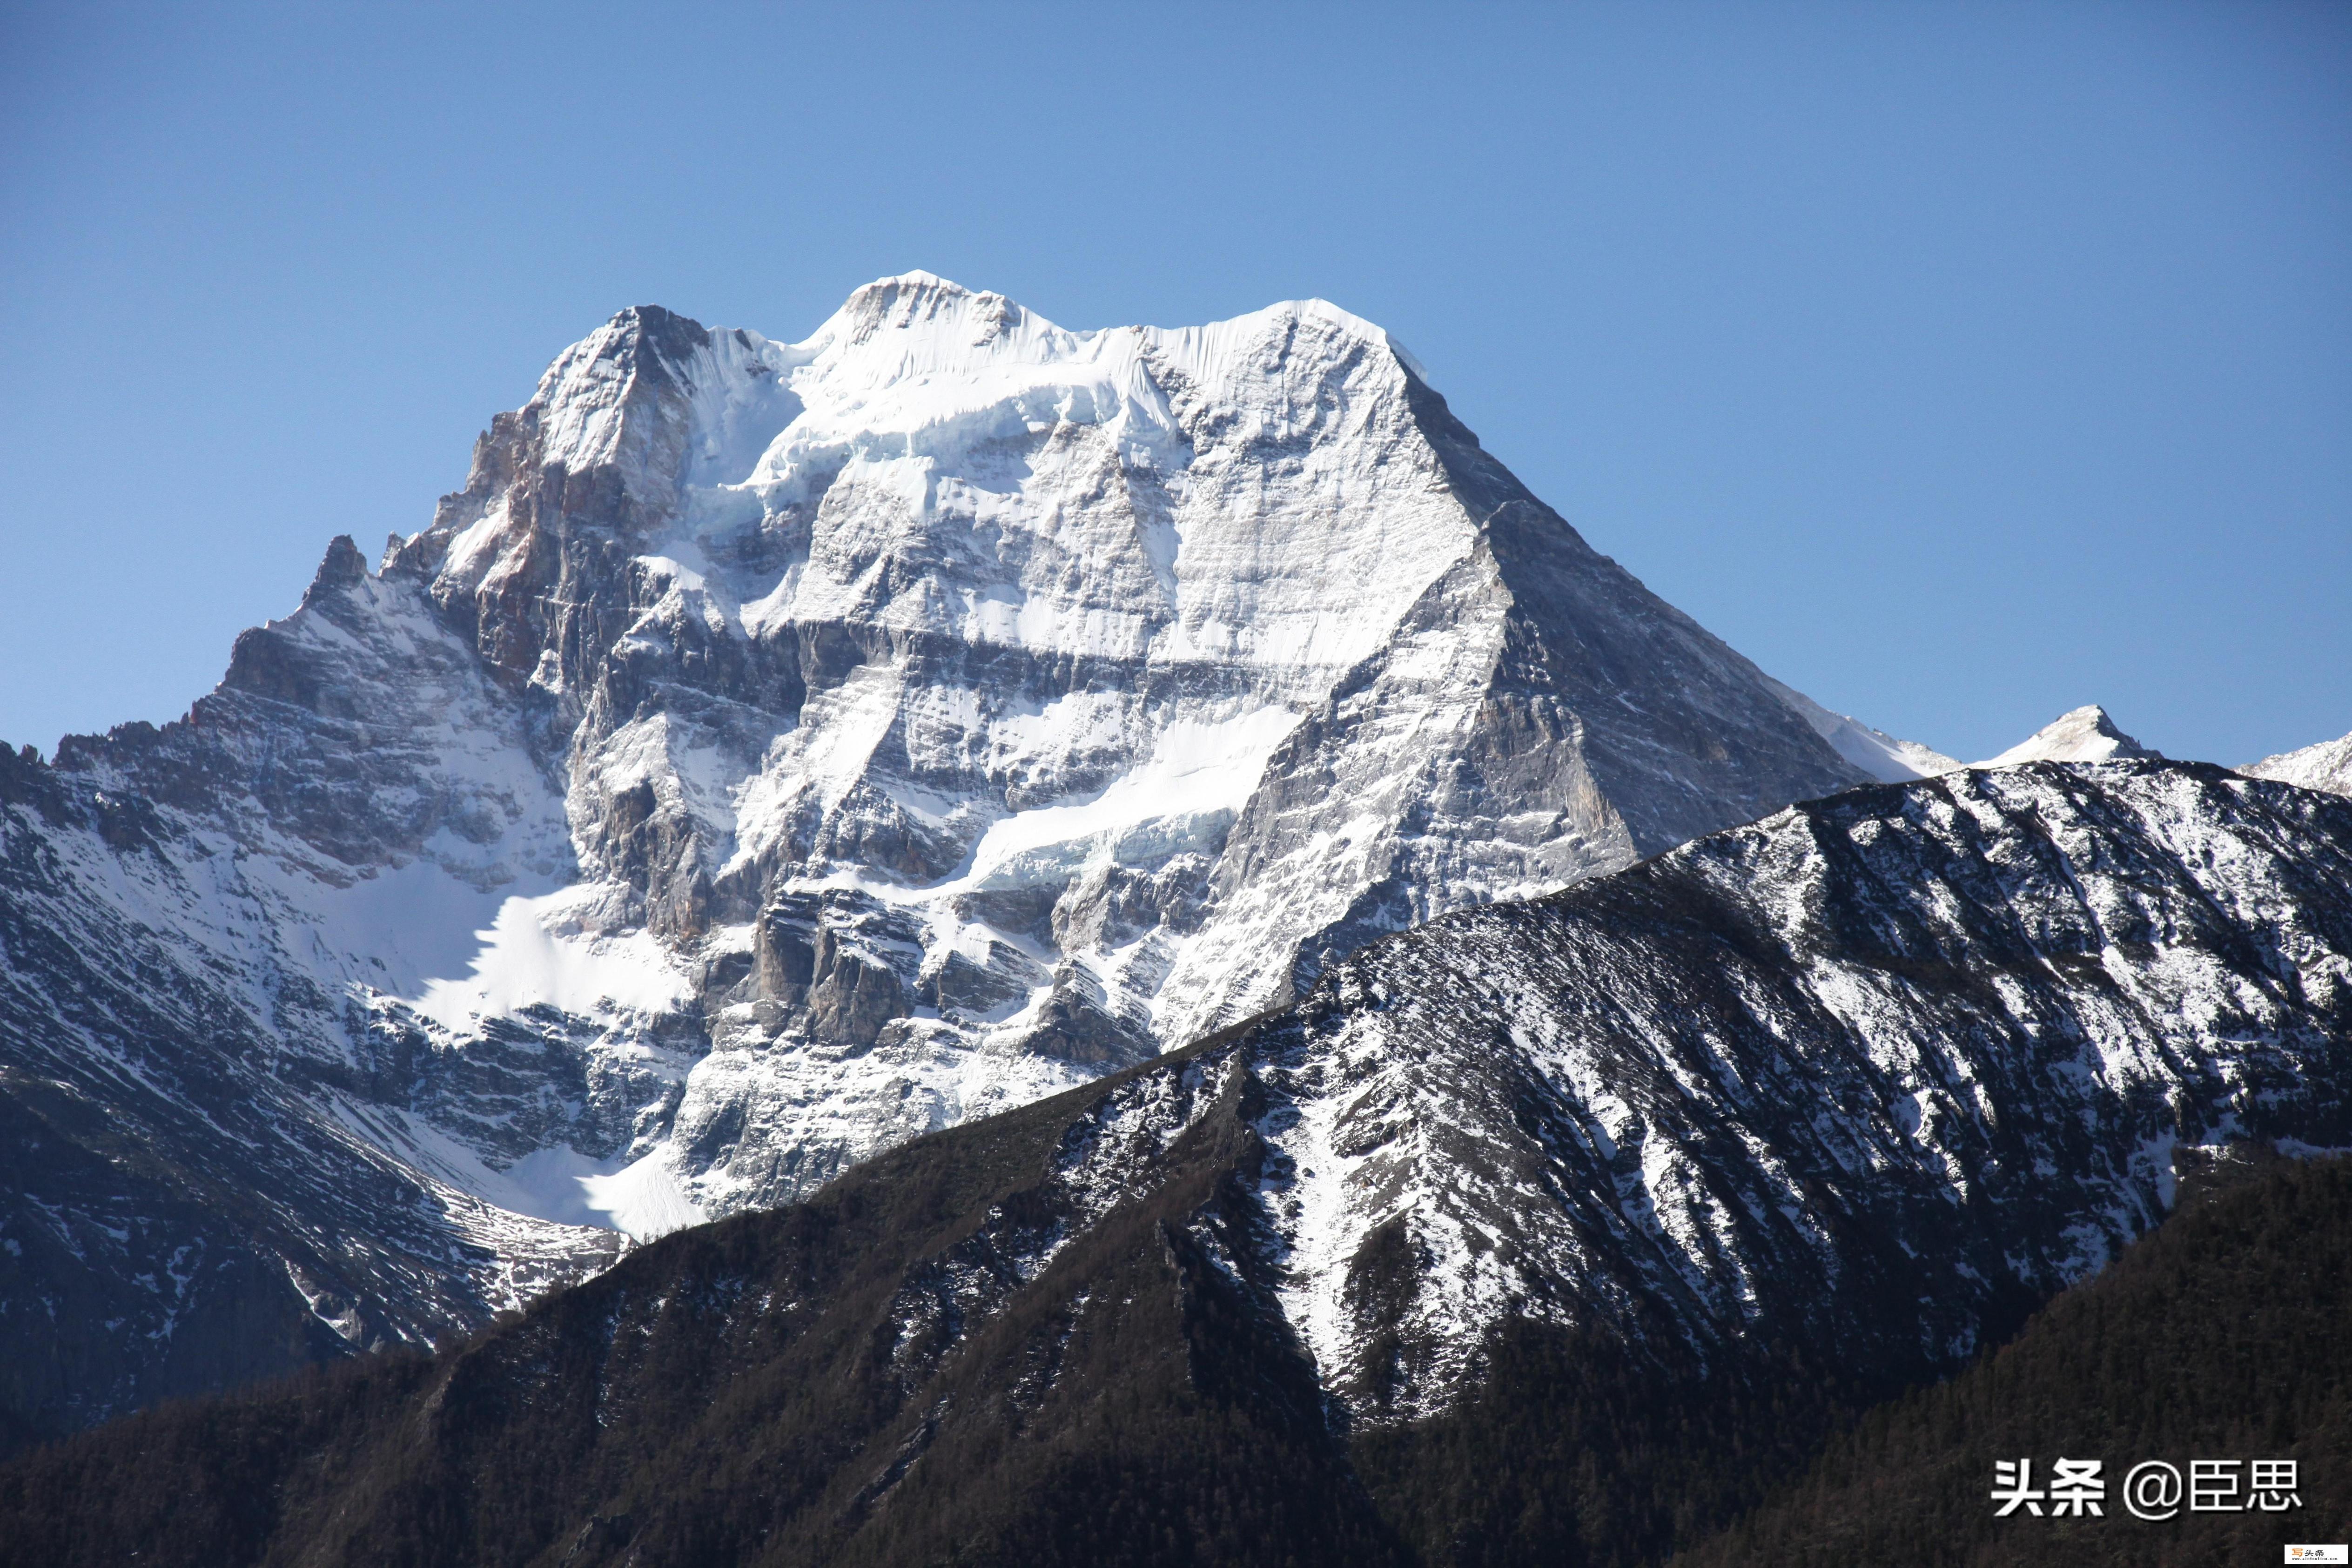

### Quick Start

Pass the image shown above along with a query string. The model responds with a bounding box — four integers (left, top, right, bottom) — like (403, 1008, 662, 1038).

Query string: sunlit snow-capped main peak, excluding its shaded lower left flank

(388, 275, 1856, 1213)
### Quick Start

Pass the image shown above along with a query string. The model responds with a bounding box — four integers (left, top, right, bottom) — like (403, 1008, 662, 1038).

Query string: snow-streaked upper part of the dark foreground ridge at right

(1249, 762, 2352, 1413)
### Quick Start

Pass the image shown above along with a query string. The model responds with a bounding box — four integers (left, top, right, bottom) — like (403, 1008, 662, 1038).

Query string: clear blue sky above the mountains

(0, 0, 2352, 762)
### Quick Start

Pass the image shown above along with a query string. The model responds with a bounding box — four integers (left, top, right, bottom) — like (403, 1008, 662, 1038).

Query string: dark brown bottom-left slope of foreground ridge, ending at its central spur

(0, 1043, 1397, 1566)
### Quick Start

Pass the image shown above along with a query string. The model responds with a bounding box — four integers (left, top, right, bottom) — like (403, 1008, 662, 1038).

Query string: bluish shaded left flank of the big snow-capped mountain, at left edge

(0, 747, 623, 1443)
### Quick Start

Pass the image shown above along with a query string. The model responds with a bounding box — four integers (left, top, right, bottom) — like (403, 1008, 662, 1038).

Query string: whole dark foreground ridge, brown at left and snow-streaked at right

(0, 759, 2352, 1563)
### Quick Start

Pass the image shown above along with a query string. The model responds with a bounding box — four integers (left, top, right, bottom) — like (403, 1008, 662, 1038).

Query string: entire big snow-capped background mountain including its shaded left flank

(0, 275, 1861, 1427)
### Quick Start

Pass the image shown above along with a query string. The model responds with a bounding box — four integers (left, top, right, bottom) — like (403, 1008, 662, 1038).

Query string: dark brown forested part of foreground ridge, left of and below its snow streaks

(0, 1039, 1854, 1568)
